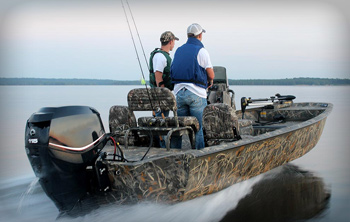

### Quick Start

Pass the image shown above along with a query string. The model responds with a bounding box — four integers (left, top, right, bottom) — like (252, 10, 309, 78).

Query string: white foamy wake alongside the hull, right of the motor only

(66, 176, 262, 222)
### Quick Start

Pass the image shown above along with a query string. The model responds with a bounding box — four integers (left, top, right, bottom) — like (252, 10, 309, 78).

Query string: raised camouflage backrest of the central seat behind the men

(128, 87, 177, 113)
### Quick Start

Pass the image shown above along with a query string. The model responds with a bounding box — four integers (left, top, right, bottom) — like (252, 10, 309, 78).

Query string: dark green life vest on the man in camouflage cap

(149, 48, 174, 90)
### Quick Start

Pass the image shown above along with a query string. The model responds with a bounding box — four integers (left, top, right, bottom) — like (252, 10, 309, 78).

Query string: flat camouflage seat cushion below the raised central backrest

(137, 116, 199, 132)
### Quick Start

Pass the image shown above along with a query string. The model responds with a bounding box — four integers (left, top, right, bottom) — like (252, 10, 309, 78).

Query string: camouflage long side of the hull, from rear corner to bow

(183, 119, 325, 200)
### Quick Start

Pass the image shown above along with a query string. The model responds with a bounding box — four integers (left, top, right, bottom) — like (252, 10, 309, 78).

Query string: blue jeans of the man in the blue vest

(176, 88, 207, 150)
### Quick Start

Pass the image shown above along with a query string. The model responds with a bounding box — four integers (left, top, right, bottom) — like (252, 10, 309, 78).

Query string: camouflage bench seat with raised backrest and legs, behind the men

(125, 87, 199, 150)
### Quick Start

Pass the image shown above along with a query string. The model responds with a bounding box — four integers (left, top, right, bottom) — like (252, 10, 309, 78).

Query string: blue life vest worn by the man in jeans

(171, 37, 208, 88)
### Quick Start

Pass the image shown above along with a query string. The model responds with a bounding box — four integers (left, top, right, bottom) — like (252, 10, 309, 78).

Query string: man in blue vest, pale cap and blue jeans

(171, 23, 215, 149)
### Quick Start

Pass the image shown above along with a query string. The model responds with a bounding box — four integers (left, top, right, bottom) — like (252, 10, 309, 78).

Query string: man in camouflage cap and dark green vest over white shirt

(149, 31, 179, 147)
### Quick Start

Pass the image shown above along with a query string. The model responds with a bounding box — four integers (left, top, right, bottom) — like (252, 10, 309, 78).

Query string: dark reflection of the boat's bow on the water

(221, 164, 330, 222)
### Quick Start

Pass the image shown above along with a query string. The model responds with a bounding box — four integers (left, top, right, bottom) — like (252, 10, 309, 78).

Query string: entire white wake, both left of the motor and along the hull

(0, 173, 262, 222)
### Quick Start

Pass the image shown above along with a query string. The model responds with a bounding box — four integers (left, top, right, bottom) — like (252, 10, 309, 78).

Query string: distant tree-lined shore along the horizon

(0, 78, 350, 86)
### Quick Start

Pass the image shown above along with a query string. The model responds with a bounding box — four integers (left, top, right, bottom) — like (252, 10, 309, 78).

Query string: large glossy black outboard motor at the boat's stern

(25, 106, 107, 211)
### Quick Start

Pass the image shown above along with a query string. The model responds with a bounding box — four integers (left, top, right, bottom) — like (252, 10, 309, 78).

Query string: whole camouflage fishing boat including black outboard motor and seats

(25, 66, 333, 212)
